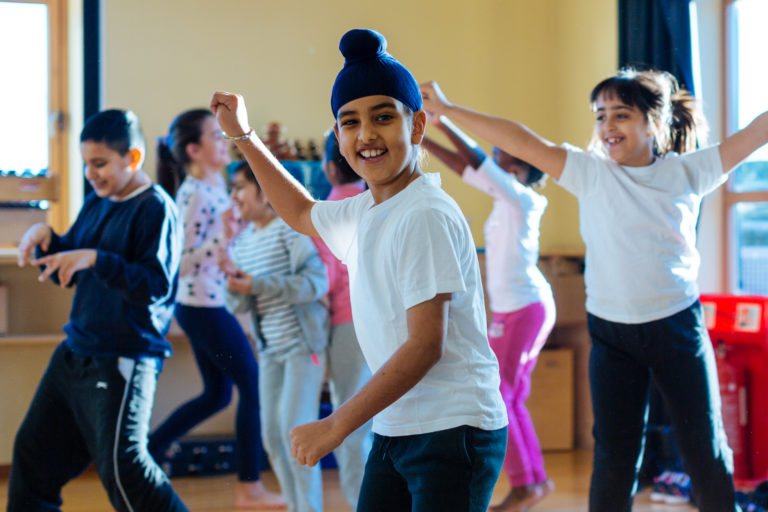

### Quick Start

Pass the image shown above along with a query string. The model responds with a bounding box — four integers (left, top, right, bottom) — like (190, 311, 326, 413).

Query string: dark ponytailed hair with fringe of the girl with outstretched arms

(589, 68, 707, 156)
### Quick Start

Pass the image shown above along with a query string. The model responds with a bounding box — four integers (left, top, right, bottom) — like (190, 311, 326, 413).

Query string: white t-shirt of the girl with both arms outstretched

(558, 146, 727, 324)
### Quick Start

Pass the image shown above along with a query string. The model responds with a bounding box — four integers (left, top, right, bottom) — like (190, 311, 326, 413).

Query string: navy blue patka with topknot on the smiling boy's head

(331, 28, 421, 117)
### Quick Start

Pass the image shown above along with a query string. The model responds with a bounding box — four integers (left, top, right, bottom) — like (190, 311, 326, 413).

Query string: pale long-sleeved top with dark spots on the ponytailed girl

(176, 175, 231, 307)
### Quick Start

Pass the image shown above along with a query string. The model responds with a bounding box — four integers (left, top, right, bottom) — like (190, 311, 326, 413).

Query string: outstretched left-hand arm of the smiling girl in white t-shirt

(420, 82, 566, 179)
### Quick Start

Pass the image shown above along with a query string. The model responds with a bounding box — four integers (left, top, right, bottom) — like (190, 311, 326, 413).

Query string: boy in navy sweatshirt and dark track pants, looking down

(8, 110, 187, 512)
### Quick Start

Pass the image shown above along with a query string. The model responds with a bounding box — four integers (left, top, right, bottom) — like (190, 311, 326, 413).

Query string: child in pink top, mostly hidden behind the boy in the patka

(313, 130, 371, 510)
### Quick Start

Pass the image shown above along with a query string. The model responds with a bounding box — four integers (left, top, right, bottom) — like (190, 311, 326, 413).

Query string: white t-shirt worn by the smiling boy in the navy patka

(312, 174, 507, 436)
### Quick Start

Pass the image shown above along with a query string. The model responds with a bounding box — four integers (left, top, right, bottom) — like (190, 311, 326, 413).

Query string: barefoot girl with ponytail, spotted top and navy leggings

(149, 109, 285, 509)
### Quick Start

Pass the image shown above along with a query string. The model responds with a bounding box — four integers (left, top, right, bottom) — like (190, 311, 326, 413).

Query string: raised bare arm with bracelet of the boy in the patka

(211, 92, 320, 238)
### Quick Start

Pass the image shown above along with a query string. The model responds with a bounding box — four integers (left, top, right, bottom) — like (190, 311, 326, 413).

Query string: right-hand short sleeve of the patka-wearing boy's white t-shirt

(395, 209, 470, 309)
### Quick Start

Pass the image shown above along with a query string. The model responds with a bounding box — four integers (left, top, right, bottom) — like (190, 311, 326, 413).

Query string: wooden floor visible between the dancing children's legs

(0, 451, 695, 512)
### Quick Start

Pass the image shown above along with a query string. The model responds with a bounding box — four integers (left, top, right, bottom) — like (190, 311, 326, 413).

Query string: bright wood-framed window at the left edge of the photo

(0, 0, 68, 229)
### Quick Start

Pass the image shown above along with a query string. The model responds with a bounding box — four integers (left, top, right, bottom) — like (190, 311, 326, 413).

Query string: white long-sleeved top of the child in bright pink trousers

(462, 157, 552, 313)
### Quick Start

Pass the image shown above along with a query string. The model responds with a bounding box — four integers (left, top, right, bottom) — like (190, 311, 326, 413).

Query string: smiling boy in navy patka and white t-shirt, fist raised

(211, 29, 507, 512)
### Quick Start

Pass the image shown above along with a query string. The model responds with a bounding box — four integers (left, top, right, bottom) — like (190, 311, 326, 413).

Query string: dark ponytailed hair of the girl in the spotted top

(157, 108, 213, 197)
